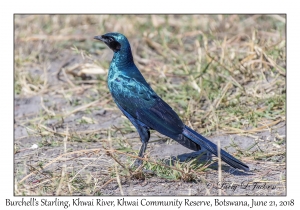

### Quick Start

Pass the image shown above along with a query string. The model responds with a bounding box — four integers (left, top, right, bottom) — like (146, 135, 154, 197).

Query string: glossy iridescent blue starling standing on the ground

(94, 33, 249, 171)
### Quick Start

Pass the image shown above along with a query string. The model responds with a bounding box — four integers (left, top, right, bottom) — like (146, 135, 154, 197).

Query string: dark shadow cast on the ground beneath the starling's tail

(162, 150, 253, 176)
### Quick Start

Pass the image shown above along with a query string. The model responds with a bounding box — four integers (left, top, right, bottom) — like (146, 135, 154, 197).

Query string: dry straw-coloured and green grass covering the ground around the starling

(14, 15, 286, 195)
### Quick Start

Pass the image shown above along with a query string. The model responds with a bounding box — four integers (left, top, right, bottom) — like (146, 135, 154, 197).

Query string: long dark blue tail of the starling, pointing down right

(183, 126, 249, 171)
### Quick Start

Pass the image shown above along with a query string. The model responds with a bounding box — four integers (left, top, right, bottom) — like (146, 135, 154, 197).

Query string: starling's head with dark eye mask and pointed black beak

(94, 33, 129, 52)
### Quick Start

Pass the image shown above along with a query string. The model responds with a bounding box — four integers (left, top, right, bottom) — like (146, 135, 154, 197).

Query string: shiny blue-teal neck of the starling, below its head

(112, 46, 133, 67)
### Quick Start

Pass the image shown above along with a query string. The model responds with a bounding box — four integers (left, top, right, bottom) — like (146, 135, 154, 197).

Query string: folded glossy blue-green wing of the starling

(111, 75, 184, 138)
